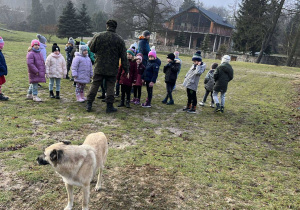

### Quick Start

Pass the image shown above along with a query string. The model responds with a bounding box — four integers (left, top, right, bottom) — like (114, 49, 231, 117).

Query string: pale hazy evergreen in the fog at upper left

(28, 0, 45, 31)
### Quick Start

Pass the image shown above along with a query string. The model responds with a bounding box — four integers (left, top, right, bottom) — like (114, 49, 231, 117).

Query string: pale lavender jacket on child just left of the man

(72, 52, 93, 84)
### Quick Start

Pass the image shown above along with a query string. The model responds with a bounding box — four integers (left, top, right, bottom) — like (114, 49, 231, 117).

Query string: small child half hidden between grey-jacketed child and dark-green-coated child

(199, 63, 218, 108)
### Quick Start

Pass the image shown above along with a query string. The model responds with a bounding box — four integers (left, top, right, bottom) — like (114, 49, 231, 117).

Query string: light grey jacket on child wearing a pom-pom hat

(183, 63, 206, 91)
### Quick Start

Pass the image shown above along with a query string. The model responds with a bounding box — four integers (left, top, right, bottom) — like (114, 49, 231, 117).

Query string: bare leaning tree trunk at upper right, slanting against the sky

(256, 0, 285, 63)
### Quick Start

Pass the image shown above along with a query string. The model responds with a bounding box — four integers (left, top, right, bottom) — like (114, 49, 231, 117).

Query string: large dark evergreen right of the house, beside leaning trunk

(233, 0, 268, 55)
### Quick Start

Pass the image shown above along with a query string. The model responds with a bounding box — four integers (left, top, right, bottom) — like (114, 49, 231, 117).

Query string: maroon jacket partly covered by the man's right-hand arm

(117, 60, 137, 86)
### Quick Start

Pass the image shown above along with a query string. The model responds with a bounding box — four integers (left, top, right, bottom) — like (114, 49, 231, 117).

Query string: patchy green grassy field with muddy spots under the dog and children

(0, 29, 300, 210)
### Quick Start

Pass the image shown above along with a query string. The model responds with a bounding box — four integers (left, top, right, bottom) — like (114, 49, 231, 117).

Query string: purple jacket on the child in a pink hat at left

(27, 50, 46, 83)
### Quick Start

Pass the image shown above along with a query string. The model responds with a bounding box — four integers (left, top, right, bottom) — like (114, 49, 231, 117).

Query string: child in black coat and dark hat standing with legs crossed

(162, 53, 180, 105)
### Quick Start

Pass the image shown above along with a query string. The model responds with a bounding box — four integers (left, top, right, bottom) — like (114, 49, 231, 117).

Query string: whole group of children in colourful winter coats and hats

(0, 34, 233, 113)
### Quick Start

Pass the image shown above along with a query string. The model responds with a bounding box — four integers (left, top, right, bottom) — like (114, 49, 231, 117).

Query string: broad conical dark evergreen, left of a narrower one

(57, 1, 81, 38)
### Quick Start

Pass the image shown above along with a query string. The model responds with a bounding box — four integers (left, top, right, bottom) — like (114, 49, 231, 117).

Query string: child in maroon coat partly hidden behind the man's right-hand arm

(117, 49, 137, 108)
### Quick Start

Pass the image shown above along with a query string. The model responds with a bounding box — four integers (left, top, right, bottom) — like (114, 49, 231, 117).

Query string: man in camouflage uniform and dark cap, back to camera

(87, 20, 128, 113)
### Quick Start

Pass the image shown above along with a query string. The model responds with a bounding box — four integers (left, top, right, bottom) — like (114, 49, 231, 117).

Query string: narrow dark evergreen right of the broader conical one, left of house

(77, 4, 93, 41)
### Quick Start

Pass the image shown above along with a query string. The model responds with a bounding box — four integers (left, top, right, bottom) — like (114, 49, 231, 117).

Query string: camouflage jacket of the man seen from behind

(89, 28, 128, 76)
